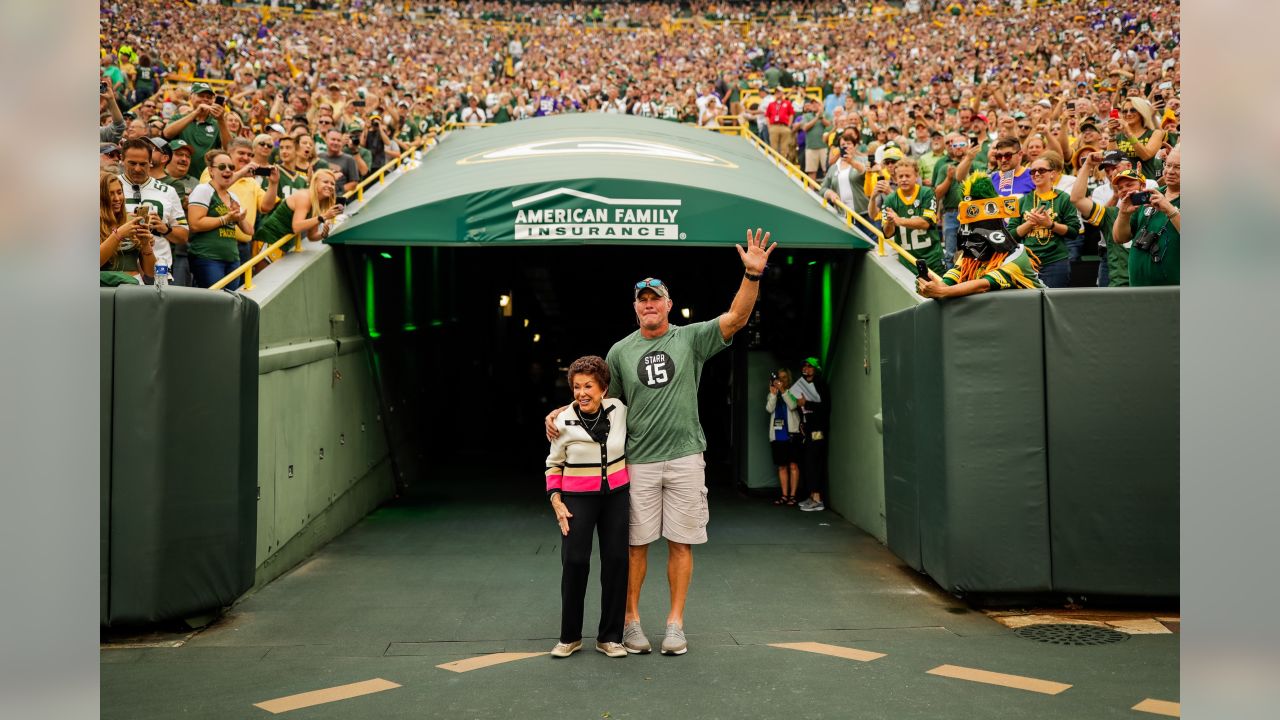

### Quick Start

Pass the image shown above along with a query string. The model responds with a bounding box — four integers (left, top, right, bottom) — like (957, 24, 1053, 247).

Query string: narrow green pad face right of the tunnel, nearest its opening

(879, 309, 924, 570)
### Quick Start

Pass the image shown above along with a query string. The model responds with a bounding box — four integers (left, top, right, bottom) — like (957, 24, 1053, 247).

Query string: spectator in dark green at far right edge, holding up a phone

(1111, 146, 1183, 287)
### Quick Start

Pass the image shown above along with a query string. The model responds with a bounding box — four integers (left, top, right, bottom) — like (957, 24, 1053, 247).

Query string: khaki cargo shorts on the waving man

(627, 452, 710, 544)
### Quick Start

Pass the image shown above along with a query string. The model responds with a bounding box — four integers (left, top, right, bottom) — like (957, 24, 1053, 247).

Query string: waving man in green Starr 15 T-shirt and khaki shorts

(547, 228, 777, 655)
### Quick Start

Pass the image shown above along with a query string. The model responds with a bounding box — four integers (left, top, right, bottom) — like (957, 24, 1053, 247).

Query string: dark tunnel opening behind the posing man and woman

(342, 240, 851, 498)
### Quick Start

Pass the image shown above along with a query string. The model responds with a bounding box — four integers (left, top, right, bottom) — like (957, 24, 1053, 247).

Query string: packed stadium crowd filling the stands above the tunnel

(100, 0, 1181, 286)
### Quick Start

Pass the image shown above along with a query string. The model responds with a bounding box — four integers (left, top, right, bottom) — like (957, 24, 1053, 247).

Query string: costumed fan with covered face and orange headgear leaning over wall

(915, 173, 1044, 297)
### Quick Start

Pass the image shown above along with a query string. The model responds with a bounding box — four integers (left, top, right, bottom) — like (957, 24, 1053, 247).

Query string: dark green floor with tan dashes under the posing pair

(101, 473, 1179, 720)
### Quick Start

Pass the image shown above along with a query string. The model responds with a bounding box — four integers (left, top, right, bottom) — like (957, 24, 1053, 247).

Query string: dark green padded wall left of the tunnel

(102, 286, 259, 624)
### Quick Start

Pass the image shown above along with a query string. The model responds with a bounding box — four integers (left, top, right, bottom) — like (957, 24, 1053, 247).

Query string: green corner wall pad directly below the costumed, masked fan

(913, 292, 1052, 593)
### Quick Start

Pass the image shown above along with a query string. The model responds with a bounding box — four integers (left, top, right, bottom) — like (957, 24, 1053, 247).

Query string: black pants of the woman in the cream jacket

(561, 489, 631, 643)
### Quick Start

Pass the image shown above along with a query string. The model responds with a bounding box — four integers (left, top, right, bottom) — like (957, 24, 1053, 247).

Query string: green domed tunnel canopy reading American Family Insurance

(329, 113, 870, 249)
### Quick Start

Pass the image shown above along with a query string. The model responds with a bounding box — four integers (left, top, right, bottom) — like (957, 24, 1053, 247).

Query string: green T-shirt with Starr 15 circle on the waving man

(607, 318, 732, 462)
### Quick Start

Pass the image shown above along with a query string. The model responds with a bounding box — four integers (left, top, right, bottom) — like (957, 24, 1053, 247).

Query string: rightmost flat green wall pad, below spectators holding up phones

(1044, 288, 1179, 597)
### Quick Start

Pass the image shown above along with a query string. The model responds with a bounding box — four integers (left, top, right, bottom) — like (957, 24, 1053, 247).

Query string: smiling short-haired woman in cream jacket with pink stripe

(547, 355, 631, 657)
